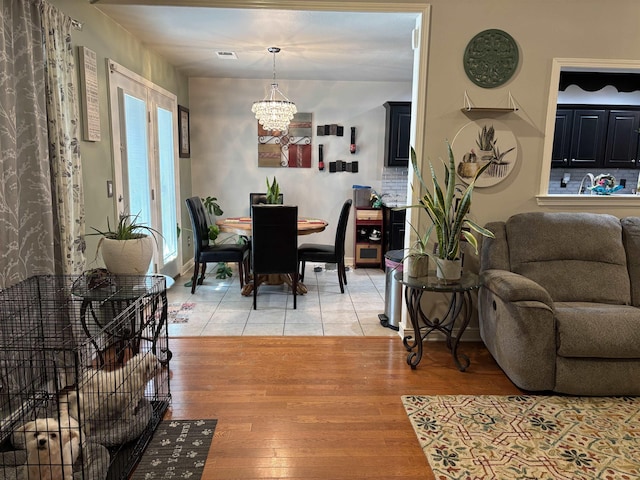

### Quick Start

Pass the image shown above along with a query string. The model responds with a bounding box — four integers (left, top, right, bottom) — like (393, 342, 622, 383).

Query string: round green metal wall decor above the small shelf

(463, 29, 518, 88)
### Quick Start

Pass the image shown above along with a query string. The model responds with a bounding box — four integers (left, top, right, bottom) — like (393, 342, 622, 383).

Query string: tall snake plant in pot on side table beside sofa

(407, 142, 493, 281)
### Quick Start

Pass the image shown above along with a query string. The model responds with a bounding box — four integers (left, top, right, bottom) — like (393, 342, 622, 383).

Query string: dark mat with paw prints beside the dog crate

(130, 420, 218, 480)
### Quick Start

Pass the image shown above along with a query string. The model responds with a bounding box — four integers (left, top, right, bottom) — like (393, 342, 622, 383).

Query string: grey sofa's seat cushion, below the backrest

(555, 302, 640, 358)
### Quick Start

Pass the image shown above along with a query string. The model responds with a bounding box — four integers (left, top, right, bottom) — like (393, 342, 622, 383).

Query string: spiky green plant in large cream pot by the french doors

(90, 213, 160, 275)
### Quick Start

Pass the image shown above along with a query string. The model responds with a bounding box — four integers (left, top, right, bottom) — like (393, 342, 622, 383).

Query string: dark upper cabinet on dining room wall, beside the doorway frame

(384, 102, 411, 167)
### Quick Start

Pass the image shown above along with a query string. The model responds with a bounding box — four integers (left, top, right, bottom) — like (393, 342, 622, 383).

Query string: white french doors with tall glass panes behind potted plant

(109, 61, 180, 277)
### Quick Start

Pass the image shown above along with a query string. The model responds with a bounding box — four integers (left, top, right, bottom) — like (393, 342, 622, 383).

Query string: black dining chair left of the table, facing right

(186, 197, 250, 293)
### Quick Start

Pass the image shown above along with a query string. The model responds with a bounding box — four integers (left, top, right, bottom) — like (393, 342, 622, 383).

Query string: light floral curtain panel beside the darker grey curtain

(42, 3, 85, 275)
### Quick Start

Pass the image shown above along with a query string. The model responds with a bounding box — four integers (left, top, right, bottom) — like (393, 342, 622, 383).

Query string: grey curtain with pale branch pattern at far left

(0, 0, 54, 288)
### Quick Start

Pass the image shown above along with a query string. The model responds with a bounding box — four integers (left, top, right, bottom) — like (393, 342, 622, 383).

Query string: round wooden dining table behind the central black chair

(216, 217, 329, 296)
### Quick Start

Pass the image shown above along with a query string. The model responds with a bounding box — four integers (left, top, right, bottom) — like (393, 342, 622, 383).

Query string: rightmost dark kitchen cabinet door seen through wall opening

(604, 110, 640, 168)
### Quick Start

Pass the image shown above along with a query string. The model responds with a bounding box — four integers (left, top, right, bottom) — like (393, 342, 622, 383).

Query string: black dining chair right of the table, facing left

(298, 199, 353, 293)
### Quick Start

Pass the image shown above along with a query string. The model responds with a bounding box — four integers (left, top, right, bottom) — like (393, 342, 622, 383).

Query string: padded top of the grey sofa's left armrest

(480, 270, 553, 309)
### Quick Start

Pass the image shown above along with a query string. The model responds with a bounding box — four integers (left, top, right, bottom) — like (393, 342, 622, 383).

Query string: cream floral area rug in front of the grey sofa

(402, 395, 640, 480)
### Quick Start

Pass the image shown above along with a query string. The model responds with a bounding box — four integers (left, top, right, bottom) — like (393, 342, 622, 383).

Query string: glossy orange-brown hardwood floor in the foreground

(162, 337, 521, 480)
